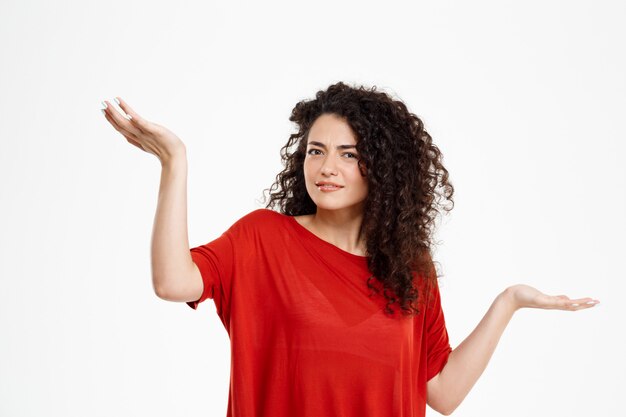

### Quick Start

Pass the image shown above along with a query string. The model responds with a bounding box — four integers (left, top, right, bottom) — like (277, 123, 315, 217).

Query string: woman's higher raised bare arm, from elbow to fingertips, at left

(103, 97, 203, 301)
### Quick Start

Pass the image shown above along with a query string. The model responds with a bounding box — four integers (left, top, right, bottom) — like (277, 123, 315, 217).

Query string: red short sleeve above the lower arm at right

(425, 281, 452, 381)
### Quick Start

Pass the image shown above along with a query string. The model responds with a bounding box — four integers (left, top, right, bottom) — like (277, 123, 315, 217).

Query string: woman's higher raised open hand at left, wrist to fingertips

(103, 97, 185, 165)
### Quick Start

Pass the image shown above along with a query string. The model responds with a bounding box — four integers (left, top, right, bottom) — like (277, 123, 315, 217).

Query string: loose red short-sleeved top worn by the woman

(187, 209, 452, 417)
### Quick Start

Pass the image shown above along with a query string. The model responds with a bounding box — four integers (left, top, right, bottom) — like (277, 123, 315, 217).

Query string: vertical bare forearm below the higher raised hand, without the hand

(151, 152, 193, 295)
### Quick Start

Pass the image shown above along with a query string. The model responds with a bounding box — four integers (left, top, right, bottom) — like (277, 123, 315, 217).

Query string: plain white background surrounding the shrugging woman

(0, 0, 626, 417)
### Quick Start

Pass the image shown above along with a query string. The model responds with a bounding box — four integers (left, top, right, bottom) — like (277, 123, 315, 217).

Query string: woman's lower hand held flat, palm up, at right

(505, 284, 600, 311)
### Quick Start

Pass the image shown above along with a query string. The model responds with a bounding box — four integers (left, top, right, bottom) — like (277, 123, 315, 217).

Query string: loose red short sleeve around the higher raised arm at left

(187, 231, 233, 315)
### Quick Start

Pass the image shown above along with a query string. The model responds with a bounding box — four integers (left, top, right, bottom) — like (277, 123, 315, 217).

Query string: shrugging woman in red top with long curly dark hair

(103, 82, 598, 417)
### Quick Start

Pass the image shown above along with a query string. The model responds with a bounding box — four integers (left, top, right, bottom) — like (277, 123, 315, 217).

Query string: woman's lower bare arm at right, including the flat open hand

(427, 284, 599, 415)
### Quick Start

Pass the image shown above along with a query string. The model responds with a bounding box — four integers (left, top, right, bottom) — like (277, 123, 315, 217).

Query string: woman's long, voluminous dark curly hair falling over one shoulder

(264, 82, 454, 315)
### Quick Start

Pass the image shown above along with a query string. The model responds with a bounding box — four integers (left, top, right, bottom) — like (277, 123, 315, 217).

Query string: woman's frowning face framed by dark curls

(304, 114, 368, 212)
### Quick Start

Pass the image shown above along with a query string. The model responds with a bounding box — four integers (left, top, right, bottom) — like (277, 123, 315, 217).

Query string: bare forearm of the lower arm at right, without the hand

(439, 290, 516, 413)
